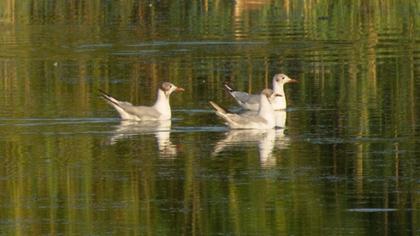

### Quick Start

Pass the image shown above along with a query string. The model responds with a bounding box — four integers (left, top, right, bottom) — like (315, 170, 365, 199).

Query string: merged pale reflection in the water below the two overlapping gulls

(213, 111, 288, 167)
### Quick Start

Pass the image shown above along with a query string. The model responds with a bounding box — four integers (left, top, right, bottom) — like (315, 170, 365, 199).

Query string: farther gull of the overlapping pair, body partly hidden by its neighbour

(225, 74, 298, 111)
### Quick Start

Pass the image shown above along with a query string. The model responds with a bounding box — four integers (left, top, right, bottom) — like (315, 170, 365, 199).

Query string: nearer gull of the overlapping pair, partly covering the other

(210, 89, 277, 129)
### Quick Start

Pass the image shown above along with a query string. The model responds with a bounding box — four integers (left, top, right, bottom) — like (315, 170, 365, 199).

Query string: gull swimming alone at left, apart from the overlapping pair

(99, 82, 184, 121)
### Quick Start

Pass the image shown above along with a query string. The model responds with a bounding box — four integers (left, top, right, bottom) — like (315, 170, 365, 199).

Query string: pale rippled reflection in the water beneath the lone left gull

(110, 120, 177, 157)
